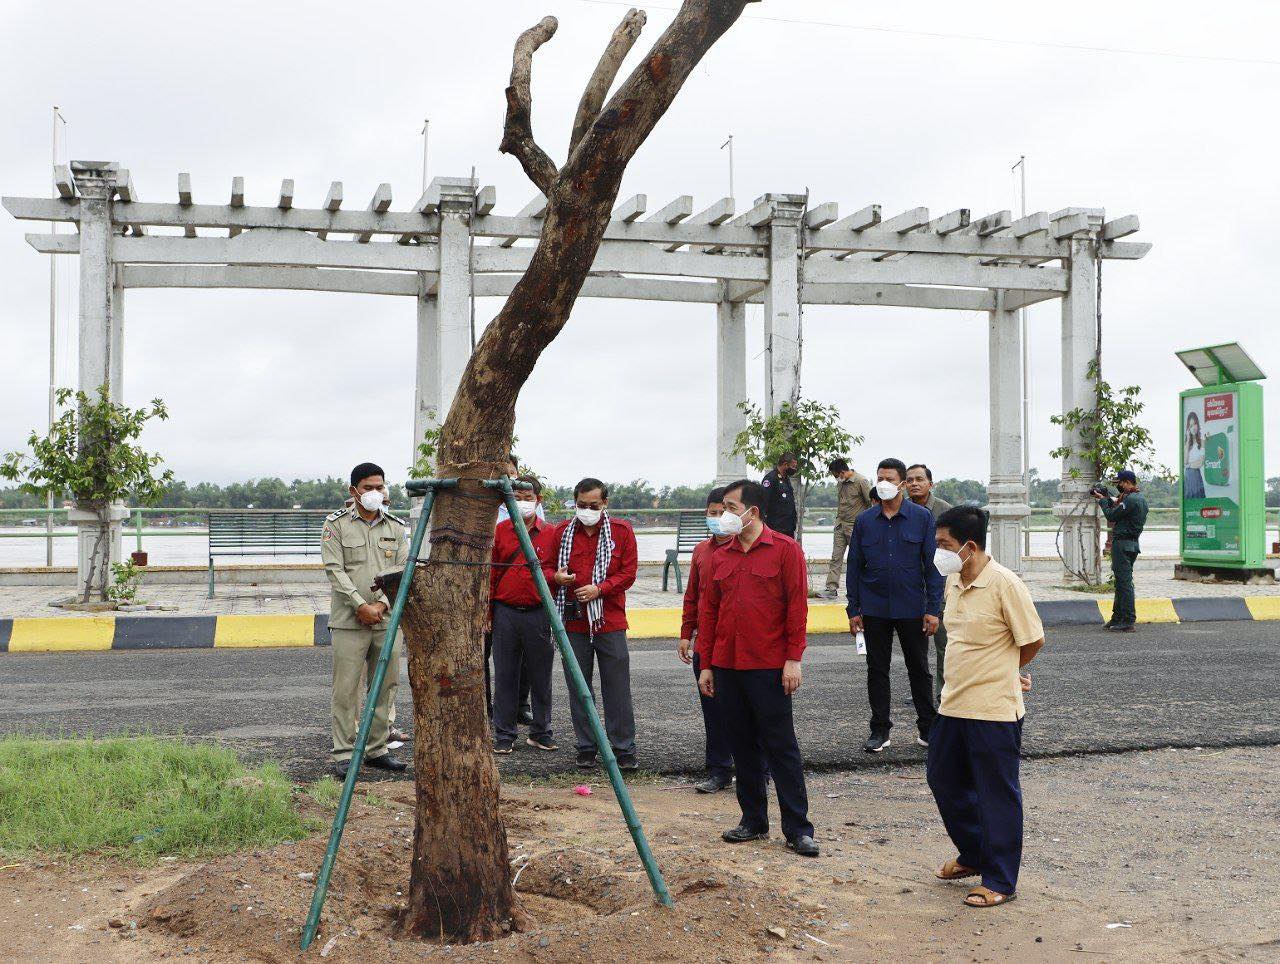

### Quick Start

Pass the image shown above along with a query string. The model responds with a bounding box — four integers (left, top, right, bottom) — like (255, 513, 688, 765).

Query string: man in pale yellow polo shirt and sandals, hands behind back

(928, 506, 1044, 908)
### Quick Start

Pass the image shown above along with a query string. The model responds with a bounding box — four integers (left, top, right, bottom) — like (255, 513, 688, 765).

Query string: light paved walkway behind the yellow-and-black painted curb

(0, 562, 1280, 618)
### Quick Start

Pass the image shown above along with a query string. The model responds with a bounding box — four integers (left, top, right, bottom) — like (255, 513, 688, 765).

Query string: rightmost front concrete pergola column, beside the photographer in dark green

(1053, 218, 1102, 575)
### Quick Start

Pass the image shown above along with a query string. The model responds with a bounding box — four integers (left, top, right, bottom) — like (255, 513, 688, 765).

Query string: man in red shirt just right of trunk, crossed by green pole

(489, 475, 558, 754)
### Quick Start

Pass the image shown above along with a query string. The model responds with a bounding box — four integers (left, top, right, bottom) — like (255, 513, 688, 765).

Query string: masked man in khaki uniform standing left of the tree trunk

(320, 462, 408, 778)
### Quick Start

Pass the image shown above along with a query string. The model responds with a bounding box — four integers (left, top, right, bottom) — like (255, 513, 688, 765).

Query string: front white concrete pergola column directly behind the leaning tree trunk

(433, 178, 475, 422)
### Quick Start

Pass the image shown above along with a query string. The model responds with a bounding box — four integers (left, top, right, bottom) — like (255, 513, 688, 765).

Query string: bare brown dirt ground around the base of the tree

(0, 748, 1280, 963)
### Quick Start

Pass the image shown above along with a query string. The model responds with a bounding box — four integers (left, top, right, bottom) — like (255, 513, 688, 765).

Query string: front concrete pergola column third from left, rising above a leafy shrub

(756, 195, 805, 415)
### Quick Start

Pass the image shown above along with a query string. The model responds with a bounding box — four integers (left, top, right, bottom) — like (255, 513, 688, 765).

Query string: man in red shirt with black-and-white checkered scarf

(556, 479, 639, 769)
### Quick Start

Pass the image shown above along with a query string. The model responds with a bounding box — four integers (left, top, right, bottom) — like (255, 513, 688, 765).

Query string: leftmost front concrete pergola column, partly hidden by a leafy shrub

(70, 161, 125, 599)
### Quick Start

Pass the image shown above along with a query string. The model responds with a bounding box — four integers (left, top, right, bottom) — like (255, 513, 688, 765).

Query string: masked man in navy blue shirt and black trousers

(846, 458, 945, 753)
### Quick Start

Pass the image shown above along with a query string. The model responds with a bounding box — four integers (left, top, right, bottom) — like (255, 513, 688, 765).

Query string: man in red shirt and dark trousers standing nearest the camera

(698, 479, 818, 856)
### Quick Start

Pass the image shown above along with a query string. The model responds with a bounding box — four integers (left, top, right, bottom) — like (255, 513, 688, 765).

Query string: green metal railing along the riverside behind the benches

(0, 503, 1280, 558)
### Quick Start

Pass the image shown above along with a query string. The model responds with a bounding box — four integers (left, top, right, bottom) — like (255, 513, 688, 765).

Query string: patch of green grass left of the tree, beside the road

(0, 736, 310, 864)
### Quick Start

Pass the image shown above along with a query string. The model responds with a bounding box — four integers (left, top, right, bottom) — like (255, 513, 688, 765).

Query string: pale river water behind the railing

(0, 526, 1178, 568)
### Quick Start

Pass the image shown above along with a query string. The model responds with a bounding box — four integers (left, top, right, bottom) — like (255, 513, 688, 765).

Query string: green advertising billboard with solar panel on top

(1178, 346, 1266, 568)
